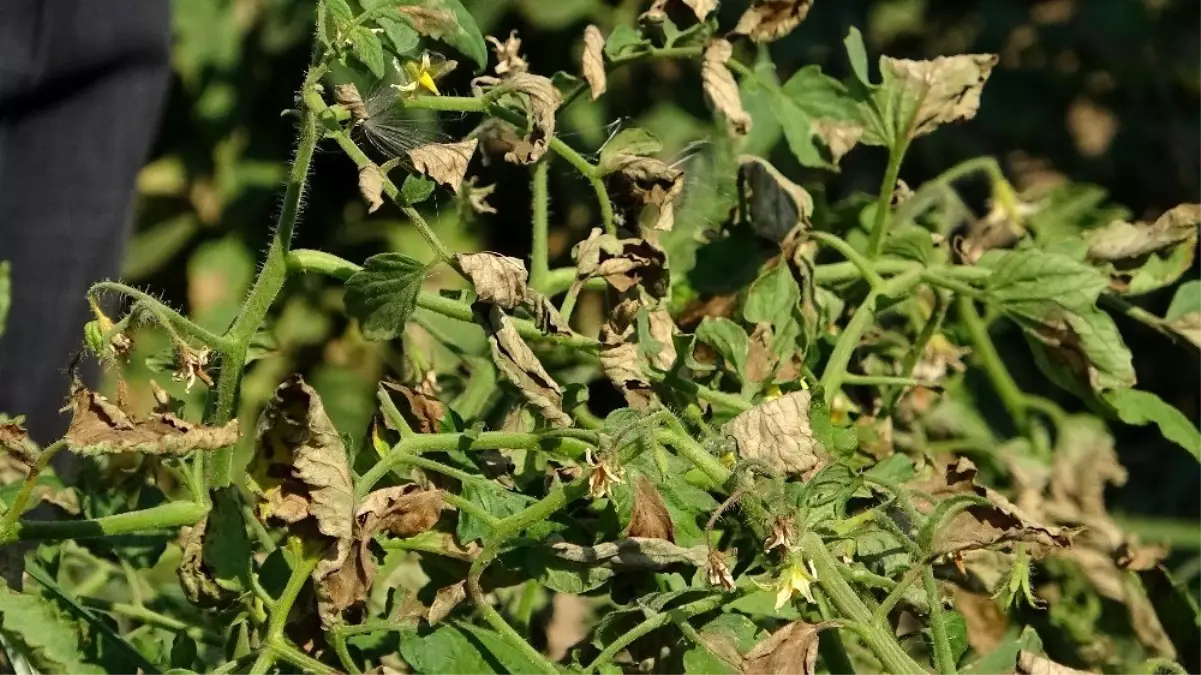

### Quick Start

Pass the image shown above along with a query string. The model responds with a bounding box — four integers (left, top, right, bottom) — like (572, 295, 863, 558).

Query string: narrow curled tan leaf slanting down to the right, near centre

(485, 306, 572, 426)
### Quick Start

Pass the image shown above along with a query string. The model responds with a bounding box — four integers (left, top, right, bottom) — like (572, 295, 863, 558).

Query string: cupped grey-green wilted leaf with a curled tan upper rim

(739, 155, 813, 244)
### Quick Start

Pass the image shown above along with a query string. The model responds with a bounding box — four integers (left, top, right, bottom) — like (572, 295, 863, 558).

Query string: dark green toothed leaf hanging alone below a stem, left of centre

(346, 253, 426, 340)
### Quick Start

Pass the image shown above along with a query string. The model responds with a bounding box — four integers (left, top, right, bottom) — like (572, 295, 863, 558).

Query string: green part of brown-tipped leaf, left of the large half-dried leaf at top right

(771, 66, 859, 168)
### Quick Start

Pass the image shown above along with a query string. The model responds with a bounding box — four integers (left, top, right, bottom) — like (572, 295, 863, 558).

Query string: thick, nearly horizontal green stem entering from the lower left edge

(0, 502, 208, 545)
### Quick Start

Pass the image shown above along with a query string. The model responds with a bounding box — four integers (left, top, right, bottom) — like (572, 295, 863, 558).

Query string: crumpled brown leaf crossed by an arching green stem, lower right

(909, 458, 1069, 555)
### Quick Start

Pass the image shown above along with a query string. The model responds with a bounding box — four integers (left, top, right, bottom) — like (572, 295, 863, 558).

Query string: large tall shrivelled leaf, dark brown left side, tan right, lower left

(249, 375, 354, 626)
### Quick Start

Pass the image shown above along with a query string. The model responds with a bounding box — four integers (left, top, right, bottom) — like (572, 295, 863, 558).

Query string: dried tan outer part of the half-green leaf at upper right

(880, 54, 997, 138)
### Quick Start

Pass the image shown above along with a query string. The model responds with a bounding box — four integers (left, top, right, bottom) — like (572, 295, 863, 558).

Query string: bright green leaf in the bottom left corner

(0, 584, 104, 675)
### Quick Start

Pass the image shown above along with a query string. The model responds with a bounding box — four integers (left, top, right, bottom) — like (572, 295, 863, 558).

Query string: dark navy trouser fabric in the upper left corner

(0, 0, 171, 443)
